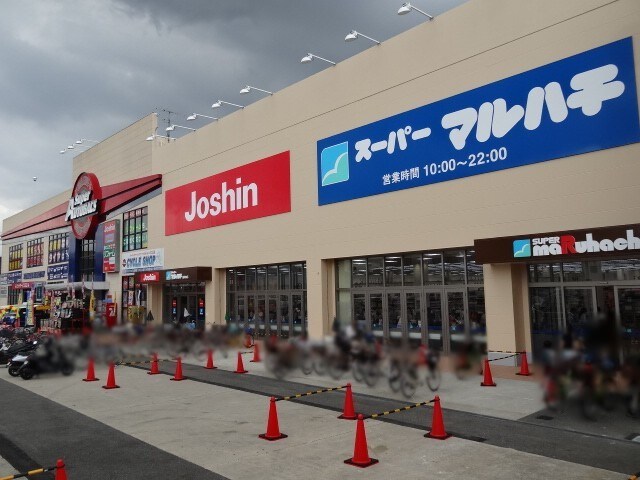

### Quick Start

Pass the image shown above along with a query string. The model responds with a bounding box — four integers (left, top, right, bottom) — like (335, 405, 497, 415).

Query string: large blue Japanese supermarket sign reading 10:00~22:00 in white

(317, 37, 640, 205)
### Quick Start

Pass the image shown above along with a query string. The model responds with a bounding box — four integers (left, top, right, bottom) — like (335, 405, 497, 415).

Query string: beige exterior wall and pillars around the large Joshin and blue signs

(150, 0, 640, 342)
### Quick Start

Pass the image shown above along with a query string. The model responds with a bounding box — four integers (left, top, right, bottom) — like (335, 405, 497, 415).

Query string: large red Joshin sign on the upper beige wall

(165, 152, 291, 235)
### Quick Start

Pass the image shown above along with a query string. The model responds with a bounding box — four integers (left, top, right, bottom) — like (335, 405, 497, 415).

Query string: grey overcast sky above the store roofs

(0, 0, 465, 231)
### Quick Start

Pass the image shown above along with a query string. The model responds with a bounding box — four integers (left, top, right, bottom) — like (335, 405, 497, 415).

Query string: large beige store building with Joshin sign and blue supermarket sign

(3, 0, 640, 360)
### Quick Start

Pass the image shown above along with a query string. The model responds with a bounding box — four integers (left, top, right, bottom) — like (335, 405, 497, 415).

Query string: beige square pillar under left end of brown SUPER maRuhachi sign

(484, 264, 531, 365)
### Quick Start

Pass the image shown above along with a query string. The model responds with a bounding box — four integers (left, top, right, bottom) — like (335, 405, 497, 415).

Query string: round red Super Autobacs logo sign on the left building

(65, 172, 102, 239)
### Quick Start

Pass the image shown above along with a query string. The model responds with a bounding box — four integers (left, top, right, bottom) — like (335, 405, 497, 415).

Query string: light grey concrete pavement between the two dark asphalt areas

(0, 367, 623, 480)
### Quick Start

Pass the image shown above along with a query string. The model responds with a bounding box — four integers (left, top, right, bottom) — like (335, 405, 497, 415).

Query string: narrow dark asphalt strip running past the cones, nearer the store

(134, 362, 640, 474)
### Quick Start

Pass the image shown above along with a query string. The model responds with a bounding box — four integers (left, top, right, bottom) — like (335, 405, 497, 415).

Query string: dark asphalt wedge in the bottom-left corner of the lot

(0, 378, 230, 480)
